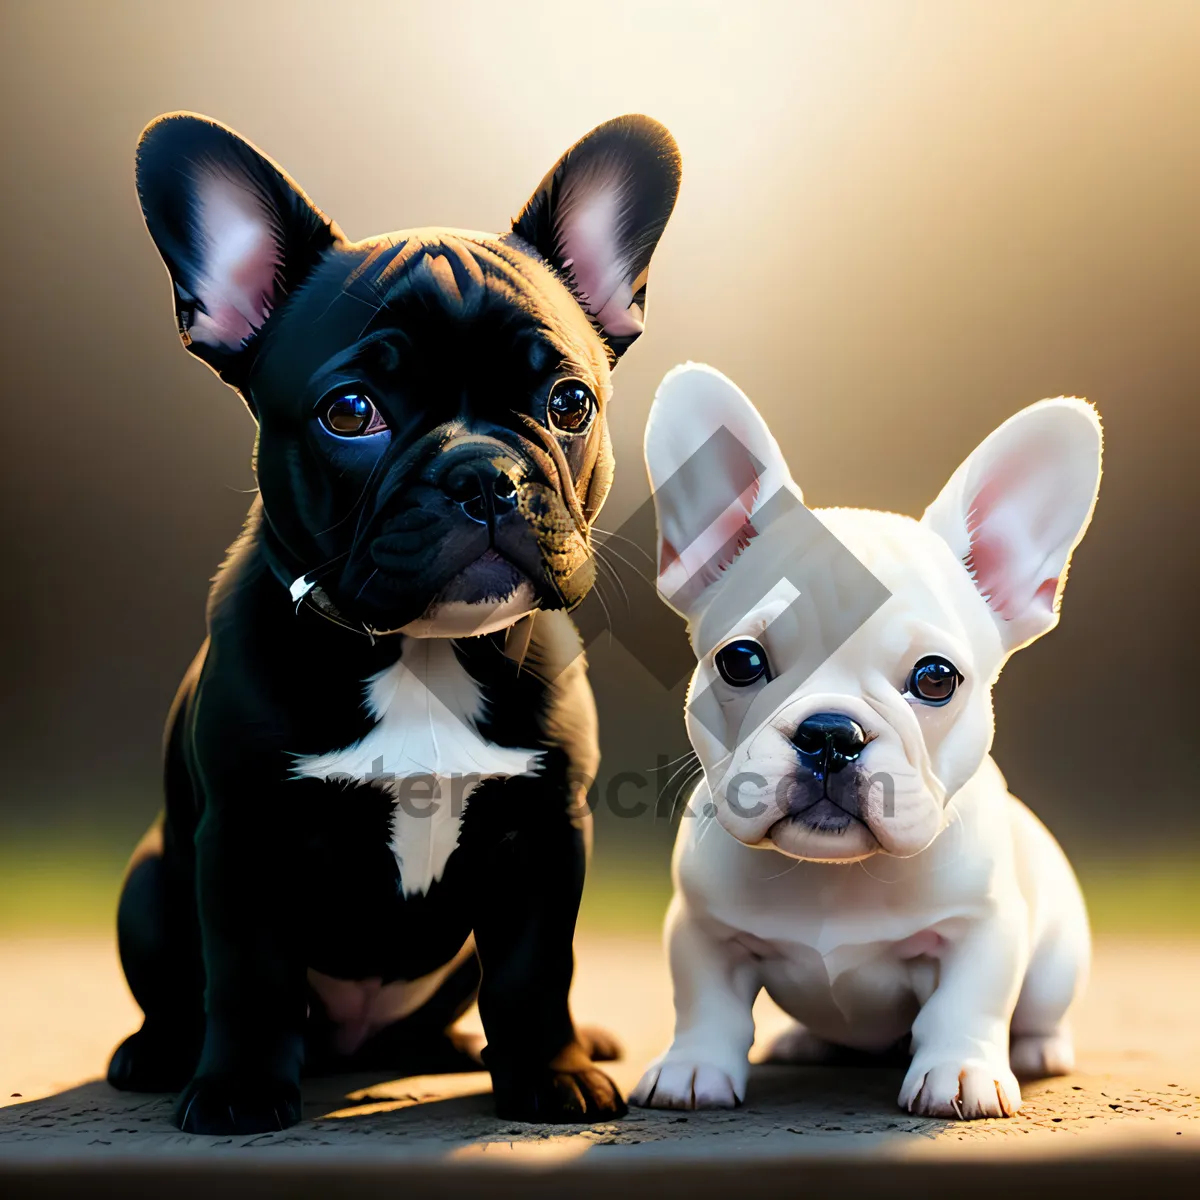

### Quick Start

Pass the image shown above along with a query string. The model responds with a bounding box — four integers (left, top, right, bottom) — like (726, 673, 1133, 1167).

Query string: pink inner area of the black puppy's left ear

(188, 175, 282, 350)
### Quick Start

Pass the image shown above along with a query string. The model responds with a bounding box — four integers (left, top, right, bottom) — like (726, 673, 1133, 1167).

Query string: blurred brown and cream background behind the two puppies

(0, 0, 1200, 920)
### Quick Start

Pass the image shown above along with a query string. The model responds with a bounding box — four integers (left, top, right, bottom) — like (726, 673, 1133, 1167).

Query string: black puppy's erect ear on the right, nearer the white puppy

(512, 115, 679, 355)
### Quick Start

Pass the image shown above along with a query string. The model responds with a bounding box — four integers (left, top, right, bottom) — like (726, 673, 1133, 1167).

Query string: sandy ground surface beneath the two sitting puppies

(0, 936, 1200, 1164)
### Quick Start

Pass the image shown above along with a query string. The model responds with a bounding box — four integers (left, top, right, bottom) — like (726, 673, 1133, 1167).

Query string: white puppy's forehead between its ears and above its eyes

(692, 506, 985, 674)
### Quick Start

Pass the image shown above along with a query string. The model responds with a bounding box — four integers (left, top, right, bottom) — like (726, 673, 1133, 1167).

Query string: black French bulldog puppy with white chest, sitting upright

(108, 114, 679, 1134)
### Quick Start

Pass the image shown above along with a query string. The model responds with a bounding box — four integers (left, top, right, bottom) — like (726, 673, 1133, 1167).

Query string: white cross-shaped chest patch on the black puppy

(292, 635, 541, 895)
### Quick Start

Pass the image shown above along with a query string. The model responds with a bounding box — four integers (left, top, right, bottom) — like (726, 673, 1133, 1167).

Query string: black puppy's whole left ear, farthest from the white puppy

(137, 113, 342, 386)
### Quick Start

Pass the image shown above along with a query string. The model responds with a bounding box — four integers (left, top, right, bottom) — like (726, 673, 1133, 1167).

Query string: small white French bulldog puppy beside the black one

(631, 365, 1100, 1120)
